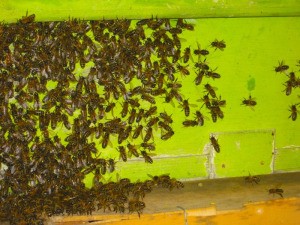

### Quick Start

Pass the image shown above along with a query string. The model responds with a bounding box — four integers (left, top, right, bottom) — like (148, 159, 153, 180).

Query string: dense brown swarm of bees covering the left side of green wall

(0, 14, 226, 224)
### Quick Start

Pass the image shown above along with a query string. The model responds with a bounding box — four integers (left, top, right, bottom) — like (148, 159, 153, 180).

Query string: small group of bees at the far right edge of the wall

(275, 60, 300, 121)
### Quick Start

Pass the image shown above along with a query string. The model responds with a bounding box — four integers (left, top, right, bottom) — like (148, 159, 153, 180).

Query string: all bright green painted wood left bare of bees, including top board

(0, 0, 300, 185)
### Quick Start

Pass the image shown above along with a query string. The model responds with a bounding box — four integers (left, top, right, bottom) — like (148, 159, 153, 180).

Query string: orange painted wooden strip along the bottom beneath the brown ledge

(52, 198, 300, 225)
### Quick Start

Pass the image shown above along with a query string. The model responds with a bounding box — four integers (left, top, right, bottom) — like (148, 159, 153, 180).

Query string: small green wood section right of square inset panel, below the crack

(274, 146, 300, 173)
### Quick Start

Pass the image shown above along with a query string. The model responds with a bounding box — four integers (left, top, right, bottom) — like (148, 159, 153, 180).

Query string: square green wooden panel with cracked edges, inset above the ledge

(212, 130, 274, 177)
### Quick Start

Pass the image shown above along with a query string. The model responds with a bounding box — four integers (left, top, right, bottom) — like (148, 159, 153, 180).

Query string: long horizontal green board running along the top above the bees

(0, 0, 300, 22)
